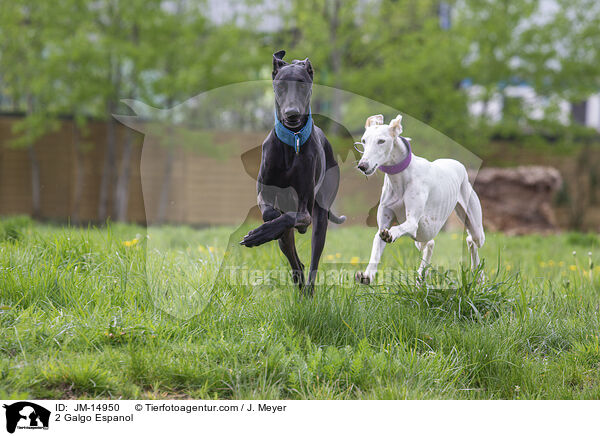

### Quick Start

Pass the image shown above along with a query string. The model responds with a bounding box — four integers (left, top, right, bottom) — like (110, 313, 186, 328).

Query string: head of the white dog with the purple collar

(358, 114, 402, 176)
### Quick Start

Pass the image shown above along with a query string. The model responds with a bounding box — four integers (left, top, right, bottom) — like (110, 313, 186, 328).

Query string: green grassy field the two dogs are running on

(0, 218, 600, 399)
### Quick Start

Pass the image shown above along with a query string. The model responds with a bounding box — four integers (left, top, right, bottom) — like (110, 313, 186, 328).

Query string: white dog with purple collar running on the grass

(356, 115, 485, 284)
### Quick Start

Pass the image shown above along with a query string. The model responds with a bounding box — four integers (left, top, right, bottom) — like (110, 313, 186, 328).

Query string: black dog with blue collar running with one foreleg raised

(240, 50, 346, 295)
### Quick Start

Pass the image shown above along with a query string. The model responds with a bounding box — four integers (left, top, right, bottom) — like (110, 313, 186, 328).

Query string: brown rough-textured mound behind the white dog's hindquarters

(469, 166, 562, 234)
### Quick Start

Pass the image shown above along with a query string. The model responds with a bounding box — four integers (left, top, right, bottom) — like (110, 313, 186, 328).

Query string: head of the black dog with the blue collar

(273, 50, 313, 130)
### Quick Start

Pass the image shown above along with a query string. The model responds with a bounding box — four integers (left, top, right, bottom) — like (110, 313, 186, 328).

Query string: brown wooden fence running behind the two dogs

(0, 115, 600, 230)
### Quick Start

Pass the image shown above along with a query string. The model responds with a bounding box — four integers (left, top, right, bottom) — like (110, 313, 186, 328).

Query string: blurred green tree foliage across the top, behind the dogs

(0, 0, 600, 150)
